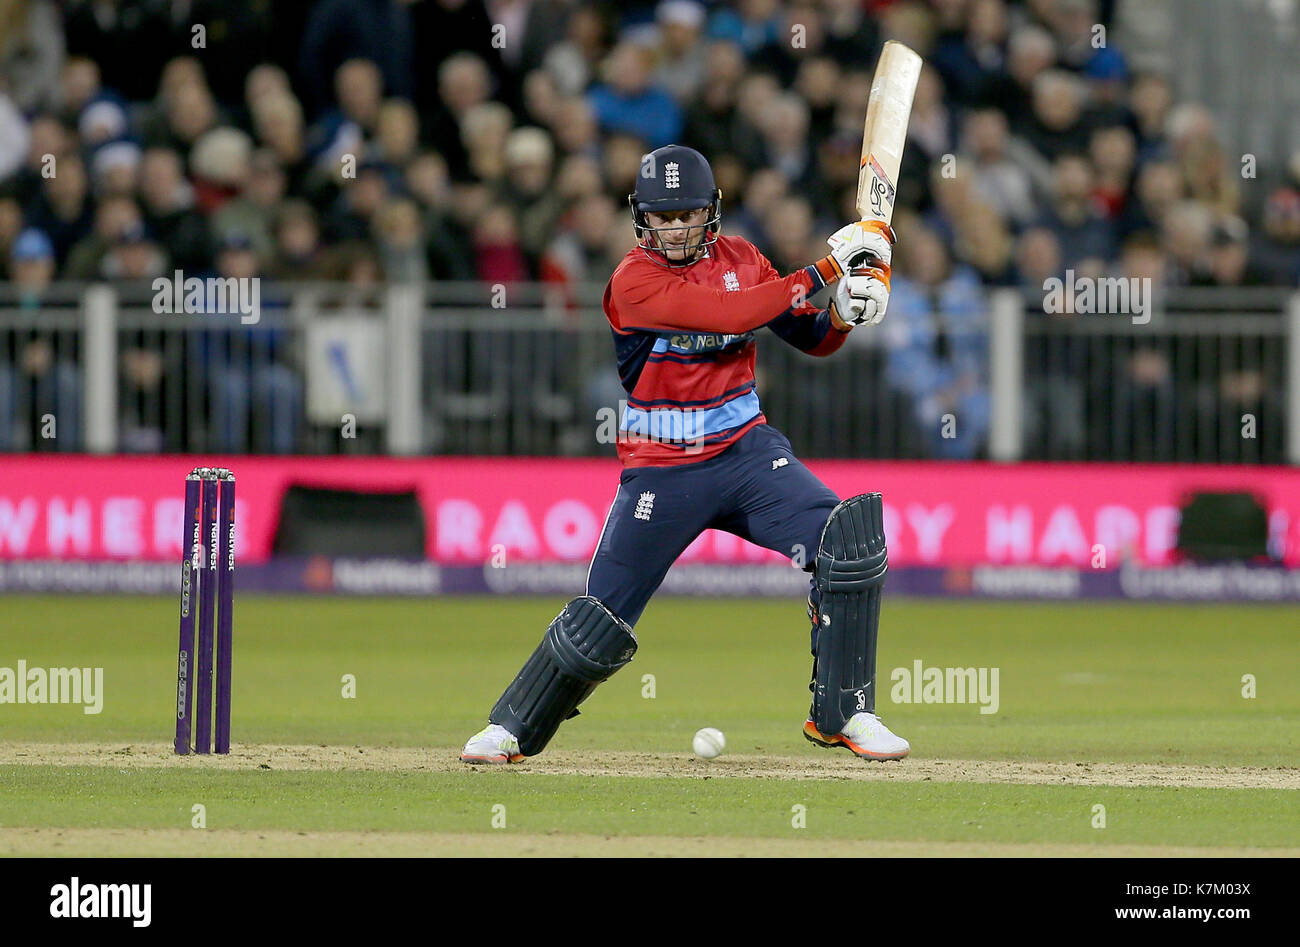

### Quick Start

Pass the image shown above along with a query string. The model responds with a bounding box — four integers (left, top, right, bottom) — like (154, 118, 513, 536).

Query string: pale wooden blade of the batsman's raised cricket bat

(858, 39, 920, 224)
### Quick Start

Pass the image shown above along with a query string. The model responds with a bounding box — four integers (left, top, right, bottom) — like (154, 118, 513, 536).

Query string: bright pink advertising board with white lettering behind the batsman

(0, 455, 1300, 568)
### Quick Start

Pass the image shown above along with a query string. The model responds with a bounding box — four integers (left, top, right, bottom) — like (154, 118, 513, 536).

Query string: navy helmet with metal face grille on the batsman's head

(628, 144, 723, 267)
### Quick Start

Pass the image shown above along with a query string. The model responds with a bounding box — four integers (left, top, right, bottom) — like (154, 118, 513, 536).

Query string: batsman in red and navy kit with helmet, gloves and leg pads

(460, 144, 910, 764)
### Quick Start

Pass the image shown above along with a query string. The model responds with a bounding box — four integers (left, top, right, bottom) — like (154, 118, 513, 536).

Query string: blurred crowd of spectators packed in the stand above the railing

(0, 0, 1300, 455)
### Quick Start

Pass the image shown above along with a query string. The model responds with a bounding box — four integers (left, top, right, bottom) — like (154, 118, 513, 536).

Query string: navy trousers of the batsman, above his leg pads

(586, 424, 840, 626)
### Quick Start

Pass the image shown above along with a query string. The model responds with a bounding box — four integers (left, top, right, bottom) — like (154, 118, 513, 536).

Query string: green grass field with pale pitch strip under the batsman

(0, 597, 1300, 856)
